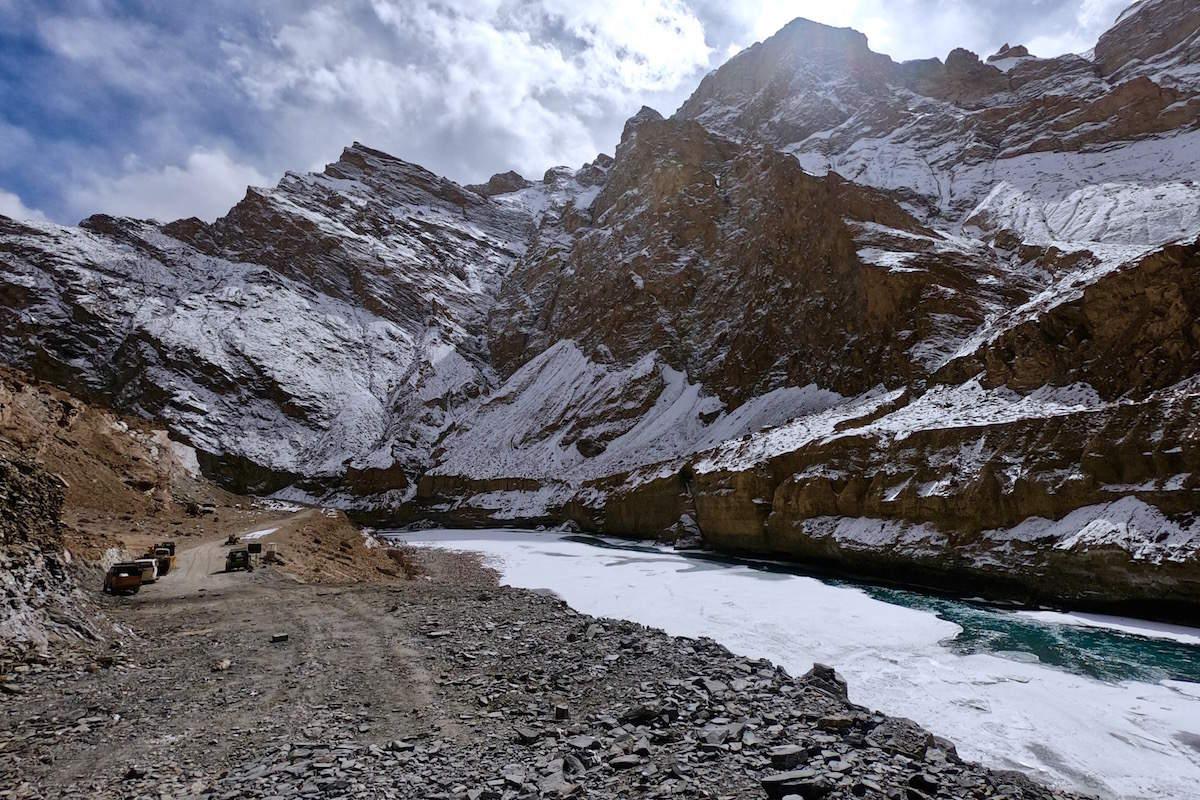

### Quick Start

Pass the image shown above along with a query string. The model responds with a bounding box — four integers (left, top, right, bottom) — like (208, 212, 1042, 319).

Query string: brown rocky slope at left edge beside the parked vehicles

(0, 369, 213, 662)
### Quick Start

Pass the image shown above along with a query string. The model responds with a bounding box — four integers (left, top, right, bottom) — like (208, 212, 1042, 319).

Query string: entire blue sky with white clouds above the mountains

(0, 0, 1127, 223)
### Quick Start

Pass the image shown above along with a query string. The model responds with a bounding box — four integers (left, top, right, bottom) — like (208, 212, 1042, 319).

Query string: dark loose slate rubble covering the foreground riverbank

(0, 555, 1089, 800)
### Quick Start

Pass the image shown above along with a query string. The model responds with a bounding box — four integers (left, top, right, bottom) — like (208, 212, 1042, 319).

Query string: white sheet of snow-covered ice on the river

(400, 530, 1200, 800)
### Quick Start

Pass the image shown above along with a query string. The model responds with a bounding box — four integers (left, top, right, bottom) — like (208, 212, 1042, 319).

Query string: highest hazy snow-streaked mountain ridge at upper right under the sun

(677, 0, 1200, 245)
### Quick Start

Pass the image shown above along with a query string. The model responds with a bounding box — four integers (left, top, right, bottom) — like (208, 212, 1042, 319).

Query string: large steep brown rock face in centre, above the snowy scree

(492, 118, 1022, 404)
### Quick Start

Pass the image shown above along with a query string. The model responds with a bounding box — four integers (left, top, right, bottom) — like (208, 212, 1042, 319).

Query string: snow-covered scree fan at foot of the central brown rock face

(433, 341, 844, 484)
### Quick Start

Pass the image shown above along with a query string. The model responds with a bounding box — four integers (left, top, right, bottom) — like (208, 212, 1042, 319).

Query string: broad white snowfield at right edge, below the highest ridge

(784, 124, 1200, 247)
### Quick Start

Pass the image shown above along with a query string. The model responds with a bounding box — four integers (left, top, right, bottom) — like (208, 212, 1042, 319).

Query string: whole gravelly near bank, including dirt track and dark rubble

(0, 527, 1072, 800)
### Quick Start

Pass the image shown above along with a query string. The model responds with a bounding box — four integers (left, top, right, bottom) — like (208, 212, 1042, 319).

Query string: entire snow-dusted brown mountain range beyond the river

(0, 0, 1200, 614)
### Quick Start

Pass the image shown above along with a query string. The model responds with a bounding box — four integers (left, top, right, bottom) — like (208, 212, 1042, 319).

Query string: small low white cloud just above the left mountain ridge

(67, 150, 269, 222)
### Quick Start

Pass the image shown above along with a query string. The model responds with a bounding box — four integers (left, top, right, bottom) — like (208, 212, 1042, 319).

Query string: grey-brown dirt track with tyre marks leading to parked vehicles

(0, 522, 460, 796)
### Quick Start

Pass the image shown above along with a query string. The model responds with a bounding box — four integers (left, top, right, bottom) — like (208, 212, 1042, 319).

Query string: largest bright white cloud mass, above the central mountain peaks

(227, 0, 712, 180)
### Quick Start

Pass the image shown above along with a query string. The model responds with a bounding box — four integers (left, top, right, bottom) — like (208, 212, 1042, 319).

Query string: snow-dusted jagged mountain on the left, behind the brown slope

(0, 145, 532, 488)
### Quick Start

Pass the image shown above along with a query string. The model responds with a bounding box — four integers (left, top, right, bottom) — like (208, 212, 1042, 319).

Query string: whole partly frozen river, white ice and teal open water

(385, 530, 1200, 800)
